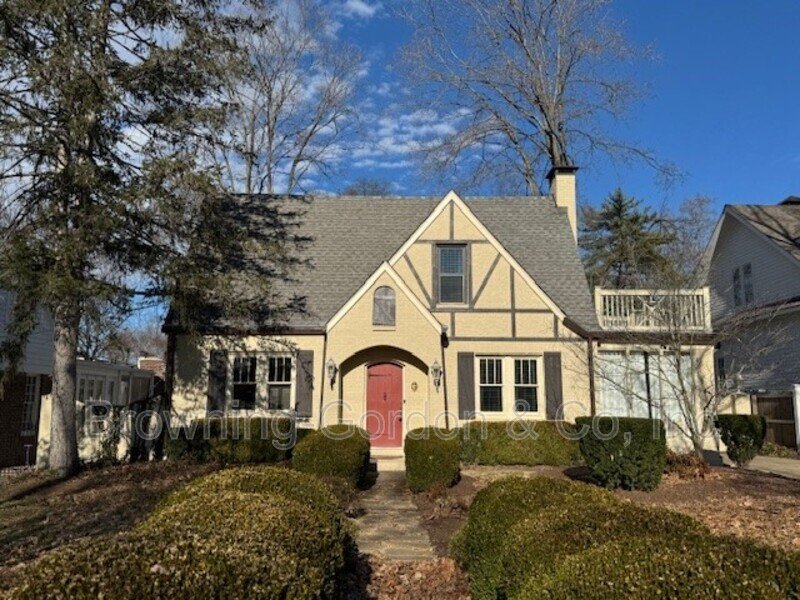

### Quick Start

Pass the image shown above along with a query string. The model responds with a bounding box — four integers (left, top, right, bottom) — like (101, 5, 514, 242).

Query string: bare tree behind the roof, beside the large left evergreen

(214, 0, 362, 194)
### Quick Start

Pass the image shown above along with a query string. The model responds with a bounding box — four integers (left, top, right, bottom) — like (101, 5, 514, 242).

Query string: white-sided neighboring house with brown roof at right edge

(707, 196, 800, 448)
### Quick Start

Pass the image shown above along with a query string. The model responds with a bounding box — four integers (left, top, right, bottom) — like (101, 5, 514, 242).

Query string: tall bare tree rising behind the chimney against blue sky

(403, 0, 674, 194)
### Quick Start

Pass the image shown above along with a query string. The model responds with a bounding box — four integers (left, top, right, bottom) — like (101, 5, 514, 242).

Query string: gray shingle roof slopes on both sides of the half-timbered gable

(247, 196, 599, 331)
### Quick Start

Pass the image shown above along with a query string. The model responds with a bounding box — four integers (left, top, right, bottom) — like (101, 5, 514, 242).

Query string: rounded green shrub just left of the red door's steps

(292, 425, 369, 487)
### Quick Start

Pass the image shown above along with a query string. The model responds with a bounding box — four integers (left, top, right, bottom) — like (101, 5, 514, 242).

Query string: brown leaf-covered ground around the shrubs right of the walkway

(415, 467, 800, 556)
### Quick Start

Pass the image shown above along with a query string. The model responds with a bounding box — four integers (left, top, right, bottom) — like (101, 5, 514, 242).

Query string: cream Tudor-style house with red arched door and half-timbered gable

(164, 168, 713, 455)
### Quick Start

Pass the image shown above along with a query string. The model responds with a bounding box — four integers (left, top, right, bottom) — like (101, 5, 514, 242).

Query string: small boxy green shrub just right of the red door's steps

(405, 427, 461, 492)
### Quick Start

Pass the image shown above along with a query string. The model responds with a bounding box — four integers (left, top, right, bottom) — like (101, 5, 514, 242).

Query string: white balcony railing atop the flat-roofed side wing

(594, 288, 711, 333)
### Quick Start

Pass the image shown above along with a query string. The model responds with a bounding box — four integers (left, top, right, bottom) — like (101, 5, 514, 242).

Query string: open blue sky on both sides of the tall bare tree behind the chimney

(333, 0, 800, 214)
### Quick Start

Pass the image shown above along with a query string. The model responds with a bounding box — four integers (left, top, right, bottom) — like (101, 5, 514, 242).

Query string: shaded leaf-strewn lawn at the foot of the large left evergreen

(0, 462, 215, 590)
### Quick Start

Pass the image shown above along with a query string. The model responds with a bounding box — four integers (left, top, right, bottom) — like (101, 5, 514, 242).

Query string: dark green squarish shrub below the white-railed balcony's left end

(575, 417, 667, 490)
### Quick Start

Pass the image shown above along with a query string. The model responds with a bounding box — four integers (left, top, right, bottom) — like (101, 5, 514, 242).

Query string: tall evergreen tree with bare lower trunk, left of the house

(0, 0, 302, 474)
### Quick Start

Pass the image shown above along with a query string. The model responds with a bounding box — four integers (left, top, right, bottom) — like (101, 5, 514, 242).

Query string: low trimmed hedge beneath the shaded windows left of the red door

(165, 417, 304, 464)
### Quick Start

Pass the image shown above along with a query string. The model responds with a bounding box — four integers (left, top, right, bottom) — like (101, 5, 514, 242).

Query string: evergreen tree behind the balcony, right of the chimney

(580, 189, 672, 289)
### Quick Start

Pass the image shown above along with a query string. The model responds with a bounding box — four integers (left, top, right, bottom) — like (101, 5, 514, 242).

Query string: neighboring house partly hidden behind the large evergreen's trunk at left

(0, 290, 154, 469)
